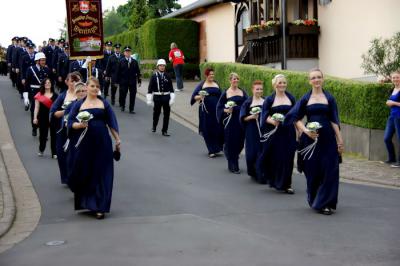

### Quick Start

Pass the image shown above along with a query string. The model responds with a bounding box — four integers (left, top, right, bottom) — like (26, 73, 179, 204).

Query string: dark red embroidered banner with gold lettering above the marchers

(65, 0, 103, 59)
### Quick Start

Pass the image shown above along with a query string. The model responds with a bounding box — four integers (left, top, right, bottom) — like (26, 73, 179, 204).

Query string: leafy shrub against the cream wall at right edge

(361, 32, 400, 79)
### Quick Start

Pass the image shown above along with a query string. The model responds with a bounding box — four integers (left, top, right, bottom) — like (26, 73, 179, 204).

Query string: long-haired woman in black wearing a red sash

(33, 78, 58, 159)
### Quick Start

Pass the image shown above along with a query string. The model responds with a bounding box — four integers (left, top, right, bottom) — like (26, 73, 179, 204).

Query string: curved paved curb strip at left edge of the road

(0, 100, 41, 253)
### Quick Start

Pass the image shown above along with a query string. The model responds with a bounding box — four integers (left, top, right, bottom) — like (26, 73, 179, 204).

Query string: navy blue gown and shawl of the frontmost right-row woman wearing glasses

(285, 90, 340, 211)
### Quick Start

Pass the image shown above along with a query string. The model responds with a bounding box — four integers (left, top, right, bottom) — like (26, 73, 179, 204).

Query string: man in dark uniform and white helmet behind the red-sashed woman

(23, 52, 50, 136)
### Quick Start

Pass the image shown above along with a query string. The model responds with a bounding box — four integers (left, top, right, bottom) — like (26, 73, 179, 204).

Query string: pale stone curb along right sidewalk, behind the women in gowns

(137, 91, 400, 189)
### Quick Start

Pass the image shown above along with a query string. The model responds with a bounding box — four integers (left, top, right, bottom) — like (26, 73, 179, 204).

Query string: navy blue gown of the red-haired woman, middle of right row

(239, 97, 261, 179)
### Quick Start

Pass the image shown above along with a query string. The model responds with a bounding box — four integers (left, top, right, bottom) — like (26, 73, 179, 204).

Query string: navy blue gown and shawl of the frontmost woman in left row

(68, 97, 118, 213)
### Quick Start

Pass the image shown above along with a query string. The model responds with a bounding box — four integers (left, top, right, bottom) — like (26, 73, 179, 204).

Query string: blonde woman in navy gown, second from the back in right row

(217, 73, 247, 174)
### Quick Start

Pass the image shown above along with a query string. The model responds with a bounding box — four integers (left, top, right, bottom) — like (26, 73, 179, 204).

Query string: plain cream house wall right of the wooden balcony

(318, 0, 400, 78)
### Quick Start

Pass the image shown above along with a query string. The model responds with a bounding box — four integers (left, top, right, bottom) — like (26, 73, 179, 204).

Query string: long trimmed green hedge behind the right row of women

(200, 63, 392, 129)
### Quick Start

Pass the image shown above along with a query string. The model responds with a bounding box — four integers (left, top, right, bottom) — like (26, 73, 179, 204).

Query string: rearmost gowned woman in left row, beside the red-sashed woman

(50, 72, 81, 184)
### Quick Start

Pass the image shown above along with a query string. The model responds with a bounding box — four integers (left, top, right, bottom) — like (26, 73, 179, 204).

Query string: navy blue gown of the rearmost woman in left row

(50, 91, 68, 184)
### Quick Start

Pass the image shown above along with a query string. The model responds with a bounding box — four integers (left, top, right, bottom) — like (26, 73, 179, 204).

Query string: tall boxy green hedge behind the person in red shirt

(107, 19, 199, 63)
